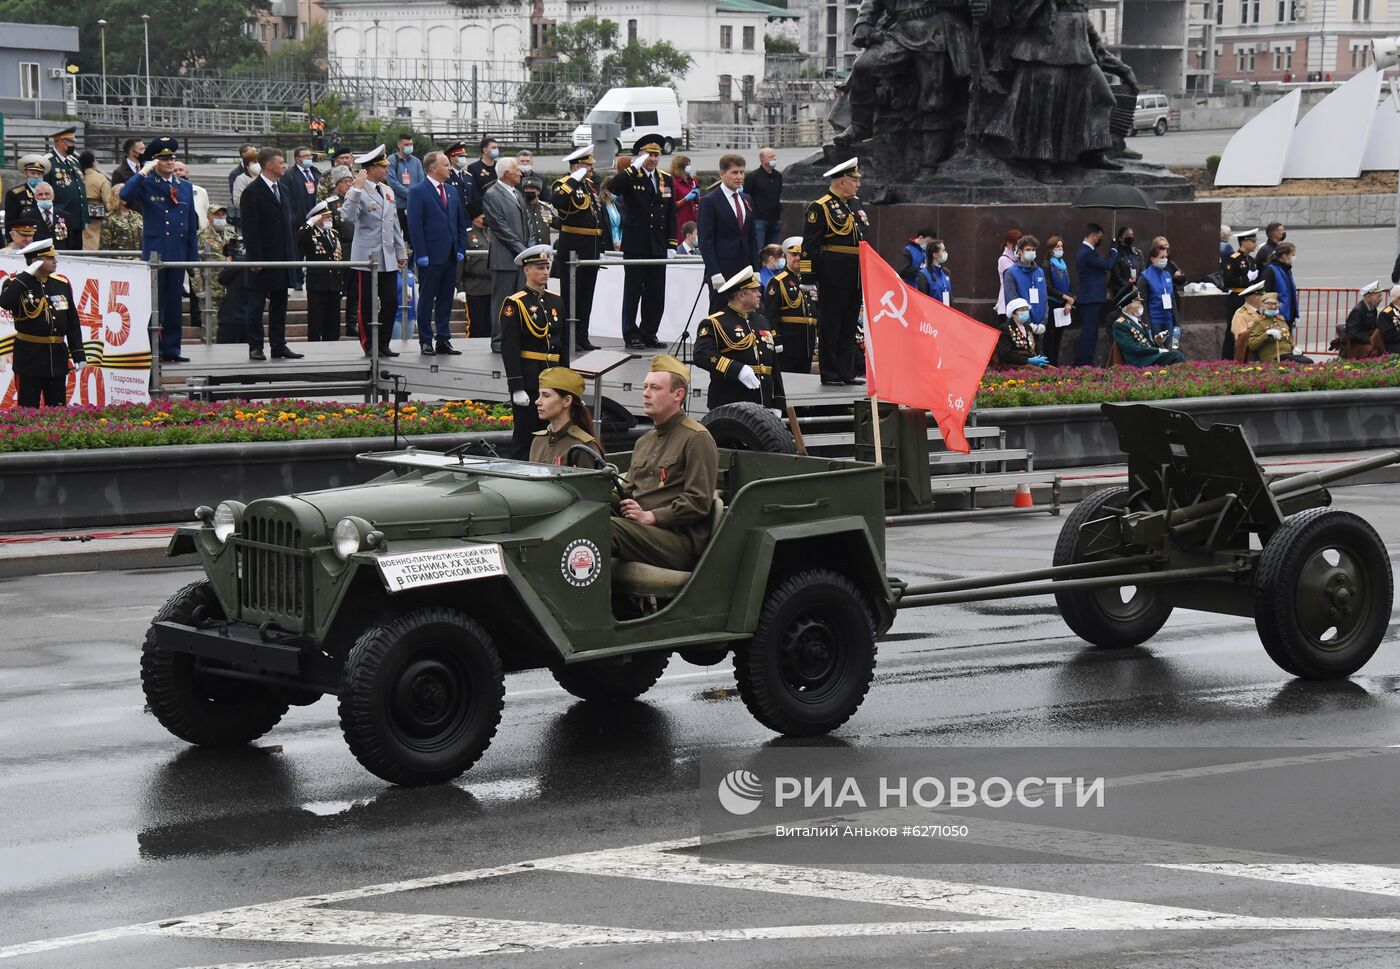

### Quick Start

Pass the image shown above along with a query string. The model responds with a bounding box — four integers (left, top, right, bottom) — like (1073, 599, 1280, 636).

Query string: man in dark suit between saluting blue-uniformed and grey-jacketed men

(239, 148, 304, 360)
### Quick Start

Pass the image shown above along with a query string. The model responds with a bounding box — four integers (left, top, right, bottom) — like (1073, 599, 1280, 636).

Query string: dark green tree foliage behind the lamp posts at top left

(0, 0, 270, 76)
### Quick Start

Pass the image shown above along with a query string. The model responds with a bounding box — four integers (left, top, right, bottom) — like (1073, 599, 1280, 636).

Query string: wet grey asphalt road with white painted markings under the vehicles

(0, 486, 1400, 969)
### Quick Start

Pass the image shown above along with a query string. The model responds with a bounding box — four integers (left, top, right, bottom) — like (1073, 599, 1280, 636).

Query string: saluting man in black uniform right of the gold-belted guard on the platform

(608, 139, 677, 350)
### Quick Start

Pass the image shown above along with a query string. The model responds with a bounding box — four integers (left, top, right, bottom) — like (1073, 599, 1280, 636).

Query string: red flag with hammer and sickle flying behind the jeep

(861, 242, 997, 454)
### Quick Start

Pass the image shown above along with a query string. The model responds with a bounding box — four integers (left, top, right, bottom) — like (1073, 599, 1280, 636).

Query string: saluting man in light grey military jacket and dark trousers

(340, 144, 409, 357)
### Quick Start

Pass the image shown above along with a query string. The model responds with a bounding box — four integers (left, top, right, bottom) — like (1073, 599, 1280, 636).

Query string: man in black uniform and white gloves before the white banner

(0, 239, 87, 407)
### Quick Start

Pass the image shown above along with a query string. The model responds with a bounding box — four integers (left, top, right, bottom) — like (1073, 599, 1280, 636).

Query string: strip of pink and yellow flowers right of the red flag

(976, 357, 1400, 409)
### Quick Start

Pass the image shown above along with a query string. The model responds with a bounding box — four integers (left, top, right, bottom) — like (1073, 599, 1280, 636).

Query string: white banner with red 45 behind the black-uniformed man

(0, 252, 151, 410)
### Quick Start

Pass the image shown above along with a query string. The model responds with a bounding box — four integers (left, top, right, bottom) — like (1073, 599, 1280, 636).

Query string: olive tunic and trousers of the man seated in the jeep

(612, 412, 720, 571)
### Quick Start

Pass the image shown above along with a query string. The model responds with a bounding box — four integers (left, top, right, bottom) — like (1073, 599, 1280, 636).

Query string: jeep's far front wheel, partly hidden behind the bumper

(141, 581, 287, 746)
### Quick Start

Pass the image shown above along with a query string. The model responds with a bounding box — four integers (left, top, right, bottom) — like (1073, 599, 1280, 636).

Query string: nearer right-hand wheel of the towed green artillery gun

(1254, 508, 1394, 679)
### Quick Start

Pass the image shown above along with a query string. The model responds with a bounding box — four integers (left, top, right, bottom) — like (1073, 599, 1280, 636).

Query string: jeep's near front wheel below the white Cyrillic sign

(340, 608, 505, 786)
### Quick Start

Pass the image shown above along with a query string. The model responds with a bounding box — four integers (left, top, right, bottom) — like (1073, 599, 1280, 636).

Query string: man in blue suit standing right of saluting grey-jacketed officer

(409, 151, 466, 356)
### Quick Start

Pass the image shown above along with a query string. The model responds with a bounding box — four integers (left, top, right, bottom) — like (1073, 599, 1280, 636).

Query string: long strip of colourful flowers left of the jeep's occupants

(0, 400, 511, 452)
